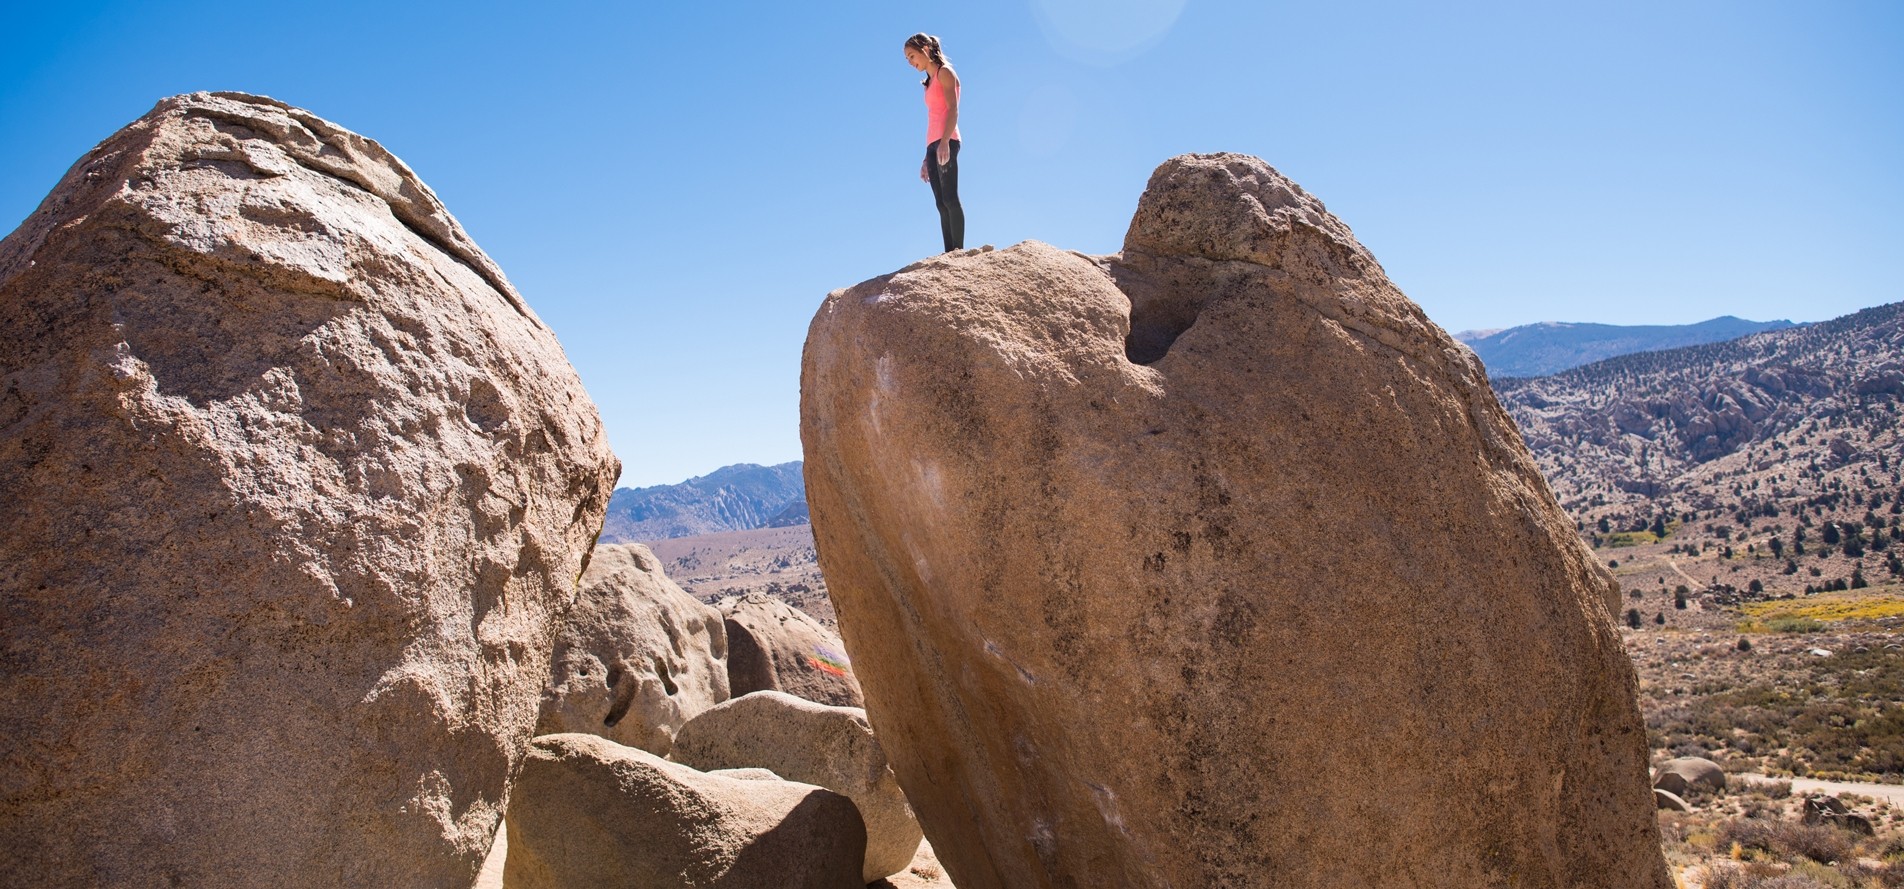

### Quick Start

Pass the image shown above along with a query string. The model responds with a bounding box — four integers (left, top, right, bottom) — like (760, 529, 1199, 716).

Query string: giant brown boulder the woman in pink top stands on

(802, 154, 1672, 889)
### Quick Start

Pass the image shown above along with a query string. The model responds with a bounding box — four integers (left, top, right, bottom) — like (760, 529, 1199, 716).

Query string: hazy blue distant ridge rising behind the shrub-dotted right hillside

(1455, 314, 1797, 379)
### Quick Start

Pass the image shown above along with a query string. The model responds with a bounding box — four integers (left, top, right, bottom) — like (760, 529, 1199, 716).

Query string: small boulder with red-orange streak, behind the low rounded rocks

(720, 592, 866, 706)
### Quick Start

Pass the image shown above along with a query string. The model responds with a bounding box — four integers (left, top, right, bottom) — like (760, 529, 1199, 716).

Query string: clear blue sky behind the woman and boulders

(0, 0, 1904, 485)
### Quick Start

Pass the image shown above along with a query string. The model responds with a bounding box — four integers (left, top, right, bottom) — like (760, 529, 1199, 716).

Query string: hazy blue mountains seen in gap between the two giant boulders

(602, 461, 807, 543)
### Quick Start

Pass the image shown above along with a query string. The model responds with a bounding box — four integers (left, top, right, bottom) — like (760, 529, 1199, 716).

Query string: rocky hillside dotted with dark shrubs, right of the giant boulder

(1495, 303, 1904, 533)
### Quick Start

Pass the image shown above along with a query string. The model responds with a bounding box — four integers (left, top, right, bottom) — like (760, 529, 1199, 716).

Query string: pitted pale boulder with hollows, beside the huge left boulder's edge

(535, 544, 727, 756)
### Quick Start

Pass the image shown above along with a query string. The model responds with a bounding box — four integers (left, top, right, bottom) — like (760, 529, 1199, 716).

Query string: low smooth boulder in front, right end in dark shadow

(503, 735, 866, 889)
